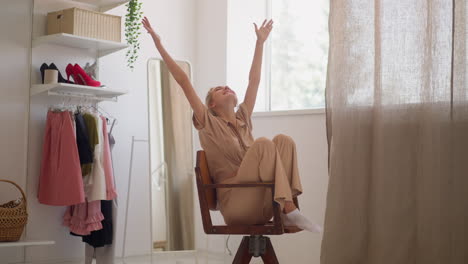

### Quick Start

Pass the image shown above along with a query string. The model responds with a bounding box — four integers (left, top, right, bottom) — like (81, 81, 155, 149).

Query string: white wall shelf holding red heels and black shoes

(30, 83, 127, 101)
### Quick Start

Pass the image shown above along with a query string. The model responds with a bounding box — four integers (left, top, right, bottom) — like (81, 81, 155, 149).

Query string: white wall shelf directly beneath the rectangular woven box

(32, 33, 128, 57)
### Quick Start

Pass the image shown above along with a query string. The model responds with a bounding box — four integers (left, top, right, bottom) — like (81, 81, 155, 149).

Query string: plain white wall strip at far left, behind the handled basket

(0, 0, 32, 263)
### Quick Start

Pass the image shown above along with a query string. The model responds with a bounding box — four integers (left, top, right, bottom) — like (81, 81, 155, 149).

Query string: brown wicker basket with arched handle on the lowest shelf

(0, 180, 28, 242)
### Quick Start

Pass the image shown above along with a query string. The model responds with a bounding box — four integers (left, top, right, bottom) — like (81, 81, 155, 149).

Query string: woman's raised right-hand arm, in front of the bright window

(244, 19, 273, 114)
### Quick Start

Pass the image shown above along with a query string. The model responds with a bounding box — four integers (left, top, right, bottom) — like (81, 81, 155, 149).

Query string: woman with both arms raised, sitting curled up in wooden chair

(142, 17, 320, 232)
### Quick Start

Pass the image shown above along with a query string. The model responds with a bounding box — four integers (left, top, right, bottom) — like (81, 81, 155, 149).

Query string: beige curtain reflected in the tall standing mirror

(161, 62, 195, 250)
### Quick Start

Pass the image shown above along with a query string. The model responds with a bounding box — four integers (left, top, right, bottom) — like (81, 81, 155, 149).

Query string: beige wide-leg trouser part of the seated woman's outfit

(218, 134, 302, 225)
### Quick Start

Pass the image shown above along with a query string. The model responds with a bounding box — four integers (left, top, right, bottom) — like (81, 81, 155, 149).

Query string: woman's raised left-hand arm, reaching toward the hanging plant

(142, 17, 205, 122)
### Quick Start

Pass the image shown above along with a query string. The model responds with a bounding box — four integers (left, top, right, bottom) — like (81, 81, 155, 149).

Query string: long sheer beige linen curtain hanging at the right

(321, 0, 468, 264)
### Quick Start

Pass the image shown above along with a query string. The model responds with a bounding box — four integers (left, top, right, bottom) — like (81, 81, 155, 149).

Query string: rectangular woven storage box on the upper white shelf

(47, 8, 122, 42)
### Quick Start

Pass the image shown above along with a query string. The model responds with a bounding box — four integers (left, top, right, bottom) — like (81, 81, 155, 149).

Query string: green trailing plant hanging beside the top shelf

(125, 0, 143, 70)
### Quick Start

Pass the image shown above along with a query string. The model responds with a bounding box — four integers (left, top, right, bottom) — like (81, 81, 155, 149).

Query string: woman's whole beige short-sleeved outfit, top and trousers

(193, 103, 302, 225)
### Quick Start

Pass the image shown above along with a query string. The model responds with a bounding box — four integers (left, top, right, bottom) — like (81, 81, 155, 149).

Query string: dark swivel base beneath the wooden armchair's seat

(232, 235, 279, 264)
